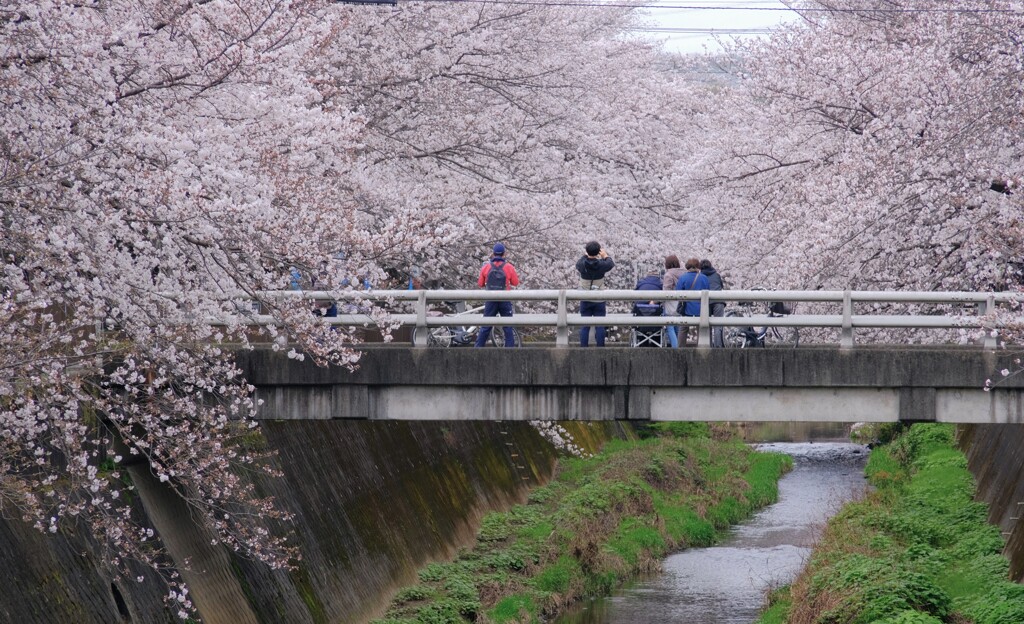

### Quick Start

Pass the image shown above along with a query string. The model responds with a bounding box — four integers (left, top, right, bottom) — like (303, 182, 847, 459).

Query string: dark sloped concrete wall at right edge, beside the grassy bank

(957, 424, 1024, 583)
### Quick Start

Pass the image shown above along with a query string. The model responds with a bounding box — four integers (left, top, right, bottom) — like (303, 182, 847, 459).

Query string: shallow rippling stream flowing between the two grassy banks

(555, 443, 867, 624)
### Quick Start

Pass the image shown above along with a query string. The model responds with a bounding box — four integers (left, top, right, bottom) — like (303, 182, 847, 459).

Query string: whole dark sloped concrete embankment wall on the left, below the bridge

(0, 420, 623, 624)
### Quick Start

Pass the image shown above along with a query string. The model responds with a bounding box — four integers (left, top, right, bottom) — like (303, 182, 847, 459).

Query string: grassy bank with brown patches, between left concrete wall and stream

(377, 426, 792, 624)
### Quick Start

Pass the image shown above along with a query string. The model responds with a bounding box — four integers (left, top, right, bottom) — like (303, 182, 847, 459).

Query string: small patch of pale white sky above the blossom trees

(644, 0, 797, 52)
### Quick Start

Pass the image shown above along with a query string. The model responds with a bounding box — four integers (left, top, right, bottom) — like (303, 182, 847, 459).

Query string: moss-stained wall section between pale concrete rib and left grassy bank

(216, 420, 631, 623)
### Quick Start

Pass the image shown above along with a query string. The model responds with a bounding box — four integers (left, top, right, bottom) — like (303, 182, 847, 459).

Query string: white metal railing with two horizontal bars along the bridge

(234, 290, 1024, 348)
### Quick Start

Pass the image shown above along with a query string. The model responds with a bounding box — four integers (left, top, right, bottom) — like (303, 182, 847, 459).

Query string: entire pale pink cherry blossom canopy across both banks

(6, 0, 1024, 611)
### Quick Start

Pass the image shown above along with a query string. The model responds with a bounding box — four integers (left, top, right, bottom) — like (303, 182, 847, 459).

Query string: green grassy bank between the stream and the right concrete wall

(760, 424, 1024, 624)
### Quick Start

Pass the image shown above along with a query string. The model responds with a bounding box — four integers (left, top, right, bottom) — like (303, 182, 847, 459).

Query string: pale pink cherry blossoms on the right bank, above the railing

(694, 0, 1024, 290)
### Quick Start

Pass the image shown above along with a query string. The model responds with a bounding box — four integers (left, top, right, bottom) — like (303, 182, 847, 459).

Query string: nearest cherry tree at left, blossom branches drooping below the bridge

(0, 0, 405, 602)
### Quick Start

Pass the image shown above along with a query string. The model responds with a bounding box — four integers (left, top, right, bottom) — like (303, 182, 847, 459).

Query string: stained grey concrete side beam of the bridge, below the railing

(239, 346, 1024, 423)
